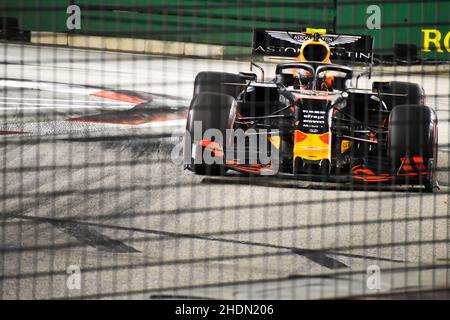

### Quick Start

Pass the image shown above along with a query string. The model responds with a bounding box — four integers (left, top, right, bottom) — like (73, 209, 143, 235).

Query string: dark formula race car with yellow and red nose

(184, 29, 438, 191)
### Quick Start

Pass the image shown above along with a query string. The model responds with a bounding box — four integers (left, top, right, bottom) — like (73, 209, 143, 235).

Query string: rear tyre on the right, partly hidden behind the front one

(372, 81, 425, 110)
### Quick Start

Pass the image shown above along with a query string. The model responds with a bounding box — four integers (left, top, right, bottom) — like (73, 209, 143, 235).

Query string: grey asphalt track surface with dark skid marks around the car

(0, 44, 450, 299)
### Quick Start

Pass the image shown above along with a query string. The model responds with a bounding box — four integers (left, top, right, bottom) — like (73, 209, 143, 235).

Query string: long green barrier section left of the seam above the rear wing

(5, 0, 335, 46)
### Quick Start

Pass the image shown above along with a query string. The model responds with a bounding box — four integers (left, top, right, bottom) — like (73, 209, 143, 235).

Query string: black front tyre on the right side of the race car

(388, 105, 438, 191)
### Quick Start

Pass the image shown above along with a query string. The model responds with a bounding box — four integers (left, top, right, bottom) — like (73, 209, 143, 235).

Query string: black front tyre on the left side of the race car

(185, 92, 236, 175)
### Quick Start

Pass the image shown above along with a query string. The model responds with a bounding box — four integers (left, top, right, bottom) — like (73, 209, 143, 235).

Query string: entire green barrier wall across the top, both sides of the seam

(0, 0, 450, 59)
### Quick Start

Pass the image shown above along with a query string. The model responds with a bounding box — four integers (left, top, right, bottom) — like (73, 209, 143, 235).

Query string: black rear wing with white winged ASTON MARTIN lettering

(252, 29, 373, 65)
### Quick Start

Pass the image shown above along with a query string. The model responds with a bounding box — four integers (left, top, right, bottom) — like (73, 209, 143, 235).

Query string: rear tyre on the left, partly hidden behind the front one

(194, 71, 245, 98)
